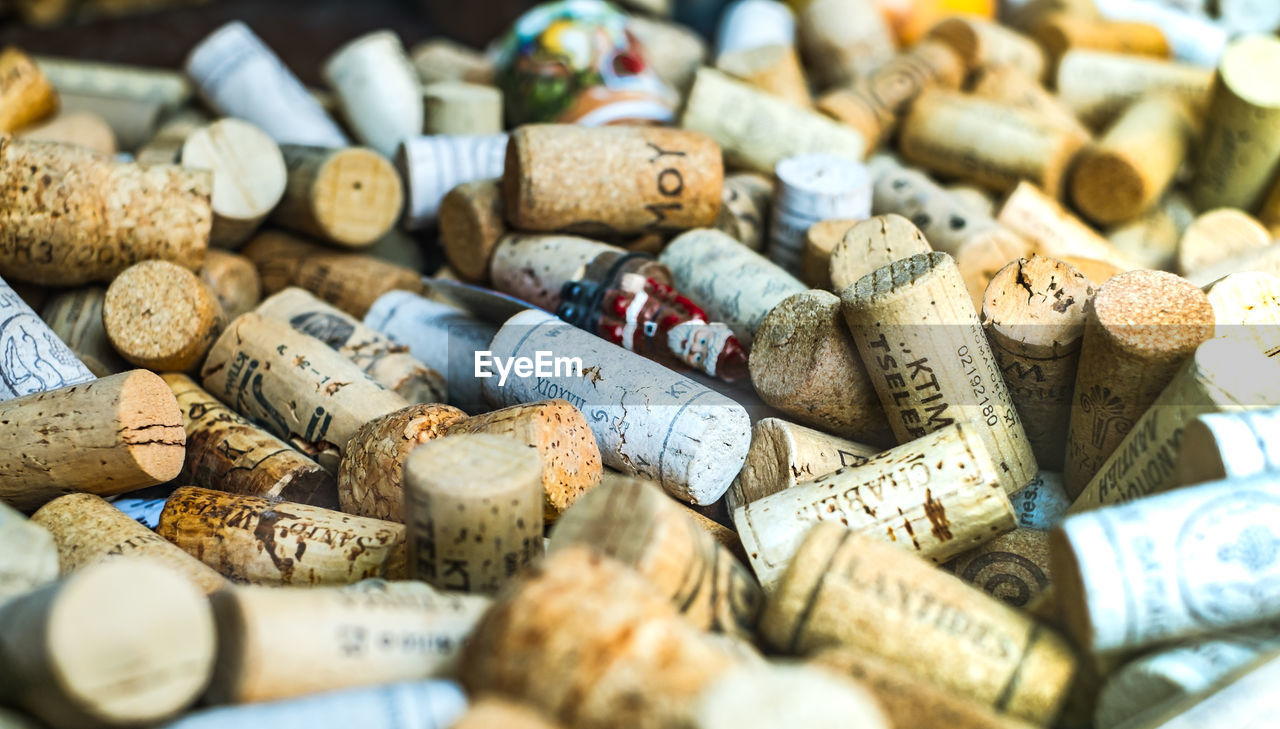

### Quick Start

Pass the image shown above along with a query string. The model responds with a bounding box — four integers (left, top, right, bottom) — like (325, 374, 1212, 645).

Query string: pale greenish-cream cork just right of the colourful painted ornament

(680, 68, 868, 174)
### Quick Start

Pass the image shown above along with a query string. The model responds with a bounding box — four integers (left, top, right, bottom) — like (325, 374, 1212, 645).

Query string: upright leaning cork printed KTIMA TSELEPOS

(841, 252, 1036, 494)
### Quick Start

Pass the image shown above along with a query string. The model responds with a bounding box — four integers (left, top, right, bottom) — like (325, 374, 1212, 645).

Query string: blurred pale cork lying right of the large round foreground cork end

(209, 582, 489, 703)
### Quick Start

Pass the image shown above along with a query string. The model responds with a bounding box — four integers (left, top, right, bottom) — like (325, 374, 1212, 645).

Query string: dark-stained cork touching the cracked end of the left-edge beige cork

(164, 373, 338, 508)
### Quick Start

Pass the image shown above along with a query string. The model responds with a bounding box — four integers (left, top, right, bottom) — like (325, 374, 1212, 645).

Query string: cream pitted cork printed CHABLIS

(733, 423, 1016, 592)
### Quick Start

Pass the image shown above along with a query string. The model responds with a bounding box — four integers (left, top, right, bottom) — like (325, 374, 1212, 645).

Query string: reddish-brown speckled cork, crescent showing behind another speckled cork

(338, 404, 467, 522)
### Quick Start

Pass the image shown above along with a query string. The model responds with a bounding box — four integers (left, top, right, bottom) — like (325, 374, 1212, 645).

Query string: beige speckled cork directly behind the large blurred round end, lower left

(31, 494, 228, 593)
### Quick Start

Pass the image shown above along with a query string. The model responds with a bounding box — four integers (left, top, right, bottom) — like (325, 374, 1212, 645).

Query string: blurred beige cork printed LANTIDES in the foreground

(760, 523, 1075, 724)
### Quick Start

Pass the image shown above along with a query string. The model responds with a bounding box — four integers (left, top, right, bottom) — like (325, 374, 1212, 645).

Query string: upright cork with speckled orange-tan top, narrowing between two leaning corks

(1062, 271, 1213, 499)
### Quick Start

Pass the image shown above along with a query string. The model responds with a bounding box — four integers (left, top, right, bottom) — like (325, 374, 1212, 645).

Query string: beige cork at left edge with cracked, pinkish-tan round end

(0, 370, 186, 510)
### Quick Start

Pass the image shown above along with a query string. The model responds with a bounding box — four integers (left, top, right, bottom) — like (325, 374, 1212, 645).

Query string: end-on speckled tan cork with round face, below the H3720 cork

(102, 261, 227, 372)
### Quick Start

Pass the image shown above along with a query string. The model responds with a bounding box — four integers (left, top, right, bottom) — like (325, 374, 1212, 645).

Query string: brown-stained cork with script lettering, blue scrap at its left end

(156, 486, 406, 584)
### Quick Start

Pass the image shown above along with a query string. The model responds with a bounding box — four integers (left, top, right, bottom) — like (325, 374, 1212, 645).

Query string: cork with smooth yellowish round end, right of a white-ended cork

(271, 145, 404, 248)
